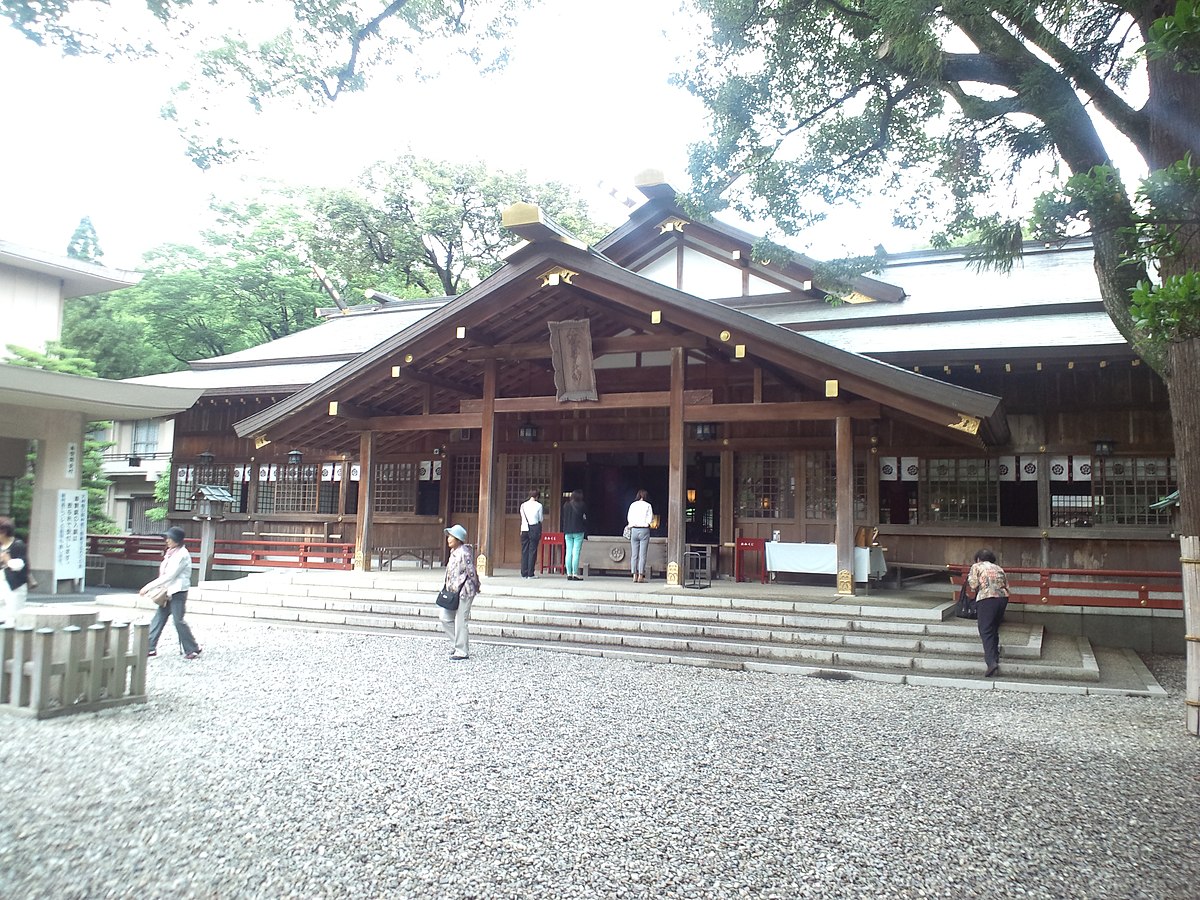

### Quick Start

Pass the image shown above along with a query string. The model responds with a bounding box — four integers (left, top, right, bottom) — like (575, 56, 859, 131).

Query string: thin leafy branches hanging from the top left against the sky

(0, 0, 530, 168)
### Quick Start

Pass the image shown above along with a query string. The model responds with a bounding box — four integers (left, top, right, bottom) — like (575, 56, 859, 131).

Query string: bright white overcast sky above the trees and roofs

(0, 0, 916, 268)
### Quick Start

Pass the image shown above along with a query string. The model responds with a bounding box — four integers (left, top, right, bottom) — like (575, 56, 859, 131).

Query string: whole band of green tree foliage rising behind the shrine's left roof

(62, 156, 602, 378)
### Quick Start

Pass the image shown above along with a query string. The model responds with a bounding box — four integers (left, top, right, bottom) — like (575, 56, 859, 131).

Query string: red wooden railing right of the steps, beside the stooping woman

(946, 565, 1183, 610)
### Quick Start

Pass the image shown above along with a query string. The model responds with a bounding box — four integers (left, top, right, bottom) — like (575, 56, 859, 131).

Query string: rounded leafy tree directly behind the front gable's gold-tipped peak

(312, 155, 602, 296)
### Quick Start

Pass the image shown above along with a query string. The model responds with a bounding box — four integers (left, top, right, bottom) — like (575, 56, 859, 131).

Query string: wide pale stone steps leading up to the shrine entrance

(93, 570, 1165, 696)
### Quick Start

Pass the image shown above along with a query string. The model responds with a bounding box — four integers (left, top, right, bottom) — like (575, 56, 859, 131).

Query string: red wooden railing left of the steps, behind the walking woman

(88, 534, 354, 569)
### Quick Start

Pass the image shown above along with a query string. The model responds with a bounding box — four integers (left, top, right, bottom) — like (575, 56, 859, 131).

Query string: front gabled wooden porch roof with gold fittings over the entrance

(235, 217, 1008, 458)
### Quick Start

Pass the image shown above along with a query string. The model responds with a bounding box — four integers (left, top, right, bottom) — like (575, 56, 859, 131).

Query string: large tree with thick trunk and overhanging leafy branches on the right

(684, 0, 1200, 733)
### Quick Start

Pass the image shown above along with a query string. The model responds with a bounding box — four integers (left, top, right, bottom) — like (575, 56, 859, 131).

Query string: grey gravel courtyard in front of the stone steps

(0, 619, 1200, 899)
